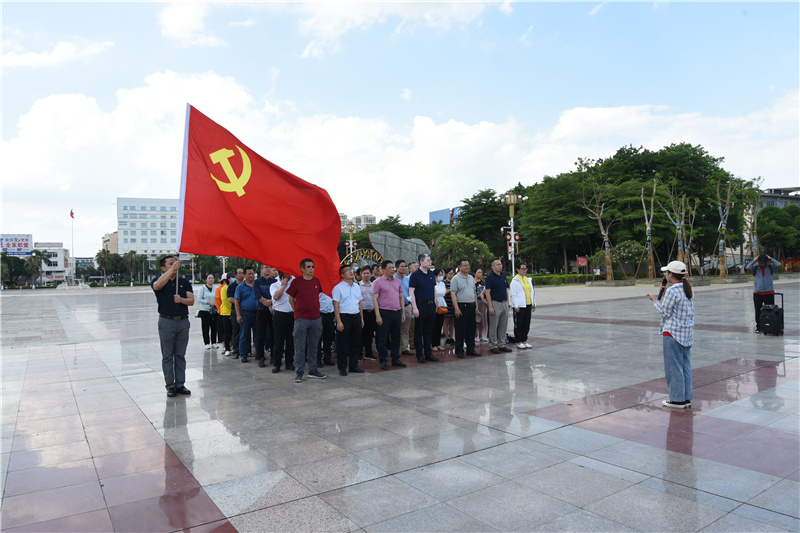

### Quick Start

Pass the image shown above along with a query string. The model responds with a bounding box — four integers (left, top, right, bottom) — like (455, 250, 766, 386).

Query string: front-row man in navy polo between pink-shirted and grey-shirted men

(408, 254, 439, 363)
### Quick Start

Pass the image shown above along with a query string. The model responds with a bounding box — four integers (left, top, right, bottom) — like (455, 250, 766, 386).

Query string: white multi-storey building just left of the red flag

(117, 198, 185, 260)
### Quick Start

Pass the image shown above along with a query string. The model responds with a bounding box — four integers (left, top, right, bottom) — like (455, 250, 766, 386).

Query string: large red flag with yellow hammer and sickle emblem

(177, 104, 342, 294)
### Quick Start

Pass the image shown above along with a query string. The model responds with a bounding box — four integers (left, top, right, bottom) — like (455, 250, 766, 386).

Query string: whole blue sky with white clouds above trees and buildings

(0, 2, 800, 256)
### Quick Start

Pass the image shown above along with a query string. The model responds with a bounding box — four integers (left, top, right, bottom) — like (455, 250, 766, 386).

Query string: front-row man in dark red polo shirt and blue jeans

(286, 259, 327, 383)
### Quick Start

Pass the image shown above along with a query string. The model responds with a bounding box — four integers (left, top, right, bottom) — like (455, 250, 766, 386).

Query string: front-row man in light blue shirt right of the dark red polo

(331, 265, 364, 376)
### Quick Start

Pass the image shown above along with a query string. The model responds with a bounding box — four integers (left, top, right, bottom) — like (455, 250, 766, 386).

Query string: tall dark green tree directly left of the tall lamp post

(456, 189, 509, 257)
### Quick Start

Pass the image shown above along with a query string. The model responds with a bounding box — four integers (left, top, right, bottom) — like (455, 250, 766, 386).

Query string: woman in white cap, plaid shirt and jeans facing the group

(647, 261, 694, 409)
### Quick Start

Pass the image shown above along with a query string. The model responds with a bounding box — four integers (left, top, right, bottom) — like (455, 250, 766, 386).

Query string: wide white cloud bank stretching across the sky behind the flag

(0, 71, 800, 256)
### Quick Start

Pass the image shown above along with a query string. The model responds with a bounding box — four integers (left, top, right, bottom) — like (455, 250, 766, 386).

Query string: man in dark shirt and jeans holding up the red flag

(150, 255, 194, 398)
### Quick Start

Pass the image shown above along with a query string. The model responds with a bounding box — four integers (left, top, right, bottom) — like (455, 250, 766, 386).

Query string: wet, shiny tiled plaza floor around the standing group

(0, 275, 800, 532)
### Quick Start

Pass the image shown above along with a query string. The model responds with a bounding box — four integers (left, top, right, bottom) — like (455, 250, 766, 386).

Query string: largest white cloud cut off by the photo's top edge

(297, 2, 484, 57)
